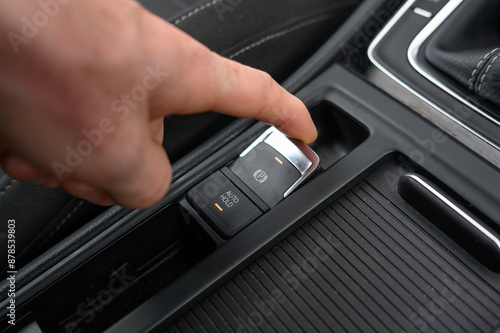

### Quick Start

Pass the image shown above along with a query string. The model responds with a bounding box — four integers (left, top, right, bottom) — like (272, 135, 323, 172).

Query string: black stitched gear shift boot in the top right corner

(425, 0, 500, 106)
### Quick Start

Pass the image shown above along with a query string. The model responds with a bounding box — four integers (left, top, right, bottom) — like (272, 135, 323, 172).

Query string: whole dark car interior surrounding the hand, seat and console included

(0, 0, 500, 333)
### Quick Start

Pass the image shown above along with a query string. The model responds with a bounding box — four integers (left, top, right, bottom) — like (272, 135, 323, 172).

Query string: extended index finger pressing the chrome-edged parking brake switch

(145, 13, 317, 143)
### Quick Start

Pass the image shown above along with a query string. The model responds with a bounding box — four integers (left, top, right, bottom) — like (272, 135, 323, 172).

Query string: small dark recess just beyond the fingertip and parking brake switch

(310, 101, 370, 171)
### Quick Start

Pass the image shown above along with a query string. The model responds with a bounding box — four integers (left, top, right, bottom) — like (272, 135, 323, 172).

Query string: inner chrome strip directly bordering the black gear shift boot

(408, 0, 500, 126)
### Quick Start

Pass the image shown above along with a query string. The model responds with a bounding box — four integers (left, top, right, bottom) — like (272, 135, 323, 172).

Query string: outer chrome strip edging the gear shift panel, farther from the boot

(368, 0, 500, 151)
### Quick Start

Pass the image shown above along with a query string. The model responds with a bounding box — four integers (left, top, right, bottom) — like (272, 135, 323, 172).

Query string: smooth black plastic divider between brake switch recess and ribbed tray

(107, 66, 500, 332)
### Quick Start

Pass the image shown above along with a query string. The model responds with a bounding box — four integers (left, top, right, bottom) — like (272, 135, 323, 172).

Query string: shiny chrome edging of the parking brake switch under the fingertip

(240, 126, 319, 198)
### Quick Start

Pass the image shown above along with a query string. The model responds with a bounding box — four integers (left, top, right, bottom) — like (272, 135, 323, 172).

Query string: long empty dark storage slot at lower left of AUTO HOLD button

(7, 205, 208, 332)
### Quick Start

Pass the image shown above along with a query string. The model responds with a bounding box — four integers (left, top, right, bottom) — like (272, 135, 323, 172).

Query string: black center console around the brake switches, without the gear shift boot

(0, 0, 500, 333)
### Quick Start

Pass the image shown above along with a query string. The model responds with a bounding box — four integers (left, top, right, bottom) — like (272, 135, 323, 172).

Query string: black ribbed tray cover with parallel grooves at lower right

(166, 160, 500, 333)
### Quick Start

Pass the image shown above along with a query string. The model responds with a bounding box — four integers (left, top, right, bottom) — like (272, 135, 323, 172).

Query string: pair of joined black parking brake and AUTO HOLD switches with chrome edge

(187, 127, 319, 238)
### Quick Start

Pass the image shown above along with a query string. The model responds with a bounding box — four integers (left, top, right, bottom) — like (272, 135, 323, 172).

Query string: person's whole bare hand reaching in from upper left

(0, 0, 317, 208)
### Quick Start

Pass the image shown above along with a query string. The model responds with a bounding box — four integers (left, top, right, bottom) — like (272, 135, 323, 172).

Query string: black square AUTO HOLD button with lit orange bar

(187, 171, 262, 238)
